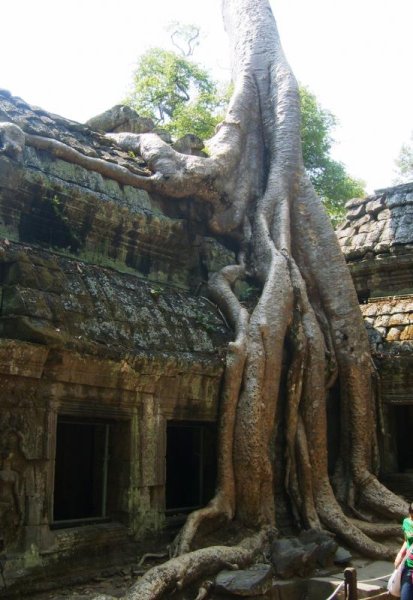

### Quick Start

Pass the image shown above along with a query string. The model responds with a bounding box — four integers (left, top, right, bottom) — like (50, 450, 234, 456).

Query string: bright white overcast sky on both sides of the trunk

(0, 0, 413, 191)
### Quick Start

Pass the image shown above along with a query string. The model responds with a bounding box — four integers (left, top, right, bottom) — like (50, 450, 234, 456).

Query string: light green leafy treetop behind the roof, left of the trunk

(126, 48, 224, 139)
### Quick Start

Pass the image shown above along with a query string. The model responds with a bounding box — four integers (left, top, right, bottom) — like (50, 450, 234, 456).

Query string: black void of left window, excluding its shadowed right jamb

(53, 418, 110, 522)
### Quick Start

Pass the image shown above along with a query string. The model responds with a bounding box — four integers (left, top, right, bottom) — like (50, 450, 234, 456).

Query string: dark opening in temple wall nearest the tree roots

(166, 422, 216, 510)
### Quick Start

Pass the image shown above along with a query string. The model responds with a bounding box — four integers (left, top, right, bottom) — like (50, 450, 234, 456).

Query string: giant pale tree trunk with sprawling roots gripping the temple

(16, 0, 407, 600)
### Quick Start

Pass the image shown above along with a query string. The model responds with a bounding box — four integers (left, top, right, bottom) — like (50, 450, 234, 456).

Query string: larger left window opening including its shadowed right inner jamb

(51, 415, 130, 528)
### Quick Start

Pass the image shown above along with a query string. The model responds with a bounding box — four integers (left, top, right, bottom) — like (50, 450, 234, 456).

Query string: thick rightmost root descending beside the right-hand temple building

(293, 173, 407, 518)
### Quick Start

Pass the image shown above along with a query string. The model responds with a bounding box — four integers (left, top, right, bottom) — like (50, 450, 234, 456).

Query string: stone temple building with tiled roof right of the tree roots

(337, 183, 413, 478)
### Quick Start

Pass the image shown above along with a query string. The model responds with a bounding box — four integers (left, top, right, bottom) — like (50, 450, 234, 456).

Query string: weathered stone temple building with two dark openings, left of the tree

(0, 91, 232, 586)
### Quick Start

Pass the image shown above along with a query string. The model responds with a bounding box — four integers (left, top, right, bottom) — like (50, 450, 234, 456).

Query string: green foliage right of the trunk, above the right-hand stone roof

(300, 87, 365, 224)
